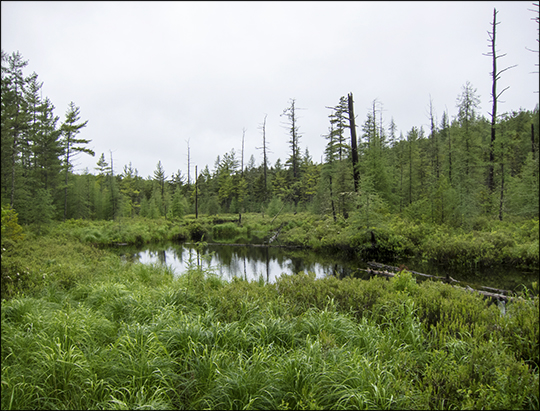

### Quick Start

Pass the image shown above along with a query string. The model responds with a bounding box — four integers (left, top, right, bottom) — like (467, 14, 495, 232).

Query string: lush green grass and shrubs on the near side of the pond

(1, 230, 539, 409)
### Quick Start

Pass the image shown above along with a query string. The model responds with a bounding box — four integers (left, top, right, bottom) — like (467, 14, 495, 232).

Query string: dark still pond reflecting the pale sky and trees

(116, 243, 539, 291)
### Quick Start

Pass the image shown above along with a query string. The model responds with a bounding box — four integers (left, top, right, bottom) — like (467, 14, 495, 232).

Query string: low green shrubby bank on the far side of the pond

(28, 213, 540, 269)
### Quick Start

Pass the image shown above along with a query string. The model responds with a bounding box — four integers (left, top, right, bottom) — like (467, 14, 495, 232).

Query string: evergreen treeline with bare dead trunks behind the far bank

(1, 51, 539, 227)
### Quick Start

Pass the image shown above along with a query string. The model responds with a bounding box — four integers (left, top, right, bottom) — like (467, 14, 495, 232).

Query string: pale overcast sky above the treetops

(1, 1, 539, 179)
